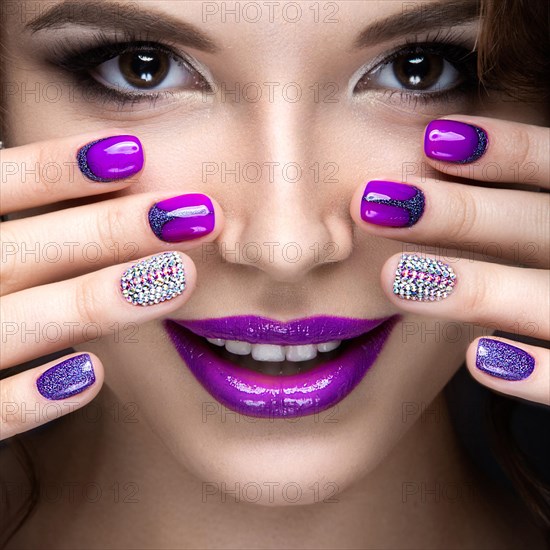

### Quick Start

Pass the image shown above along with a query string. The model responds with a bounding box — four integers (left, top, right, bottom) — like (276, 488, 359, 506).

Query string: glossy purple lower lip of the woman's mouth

(164, 316, 398, 418)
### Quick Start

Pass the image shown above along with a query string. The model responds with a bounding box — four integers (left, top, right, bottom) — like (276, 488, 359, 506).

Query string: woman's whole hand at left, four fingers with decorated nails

(0, 130, 222, 439)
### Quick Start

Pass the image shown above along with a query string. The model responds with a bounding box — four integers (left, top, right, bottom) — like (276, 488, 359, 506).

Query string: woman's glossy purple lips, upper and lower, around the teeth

(164, 315, 400, 418)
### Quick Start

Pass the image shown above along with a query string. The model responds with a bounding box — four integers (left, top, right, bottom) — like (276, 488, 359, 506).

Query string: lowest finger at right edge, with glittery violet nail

(466, 337, 550, 405)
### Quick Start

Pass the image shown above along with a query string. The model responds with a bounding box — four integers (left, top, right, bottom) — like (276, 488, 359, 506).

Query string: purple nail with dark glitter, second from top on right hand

(361, 180, 424, 227)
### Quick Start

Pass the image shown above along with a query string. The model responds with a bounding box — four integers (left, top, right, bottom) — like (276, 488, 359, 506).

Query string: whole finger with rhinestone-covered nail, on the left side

(0, 252, 196, 368)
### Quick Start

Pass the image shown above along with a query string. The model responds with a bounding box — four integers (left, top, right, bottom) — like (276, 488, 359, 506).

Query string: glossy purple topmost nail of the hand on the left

(76, 136, 143, 182)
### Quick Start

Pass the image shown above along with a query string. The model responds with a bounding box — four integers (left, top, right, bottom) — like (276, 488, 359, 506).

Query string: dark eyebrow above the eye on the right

(354, 0, 480, 48)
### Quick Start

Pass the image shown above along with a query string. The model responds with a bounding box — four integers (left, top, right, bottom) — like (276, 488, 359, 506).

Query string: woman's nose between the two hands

(221, 102, 353, 283)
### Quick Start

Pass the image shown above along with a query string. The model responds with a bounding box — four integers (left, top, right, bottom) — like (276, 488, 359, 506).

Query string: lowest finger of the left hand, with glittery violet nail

(0, 353, 104, 441)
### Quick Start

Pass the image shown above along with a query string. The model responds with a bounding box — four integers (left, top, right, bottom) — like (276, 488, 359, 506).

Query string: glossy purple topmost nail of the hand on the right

(424, 120, 488, 164)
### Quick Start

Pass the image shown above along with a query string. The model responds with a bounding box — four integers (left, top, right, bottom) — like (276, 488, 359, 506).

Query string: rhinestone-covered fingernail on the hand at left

(120, 252, 185, 306)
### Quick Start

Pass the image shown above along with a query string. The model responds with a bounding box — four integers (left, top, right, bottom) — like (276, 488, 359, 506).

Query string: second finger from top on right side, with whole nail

(350, 180, 550, 267)
